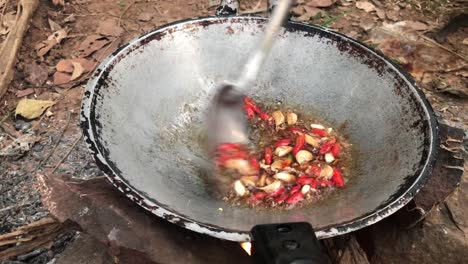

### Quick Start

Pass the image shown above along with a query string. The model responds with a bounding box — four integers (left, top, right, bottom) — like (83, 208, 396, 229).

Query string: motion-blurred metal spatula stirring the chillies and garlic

(208, 0, 293, 149)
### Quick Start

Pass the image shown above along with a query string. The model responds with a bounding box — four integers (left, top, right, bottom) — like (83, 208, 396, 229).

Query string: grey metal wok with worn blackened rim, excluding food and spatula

(81, 17, 438, 241)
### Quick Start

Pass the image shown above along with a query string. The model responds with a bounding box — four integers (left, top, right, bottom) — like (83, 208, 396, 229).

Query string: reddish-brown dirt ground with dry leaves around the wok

(0, 0, 468, 263)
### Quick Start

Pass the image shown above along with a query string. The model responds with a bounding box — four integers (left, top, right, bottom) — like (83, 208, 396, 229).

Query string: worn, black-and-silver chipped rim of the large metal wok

(80, 16, 439, 242)
